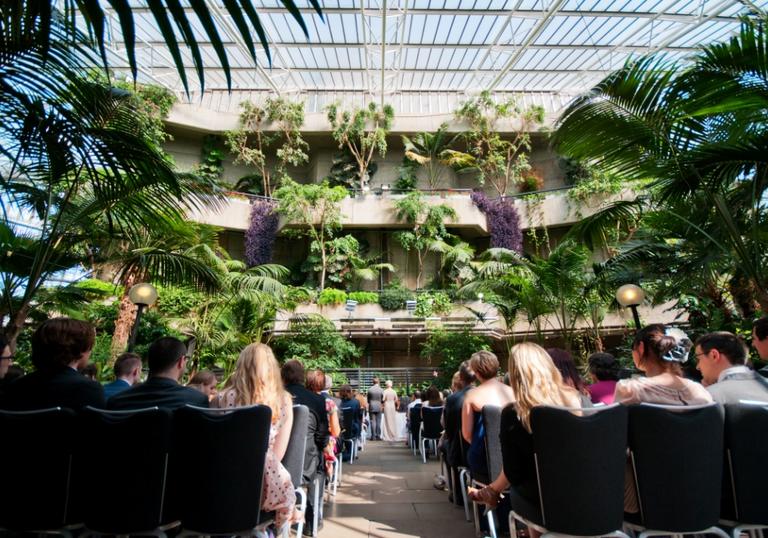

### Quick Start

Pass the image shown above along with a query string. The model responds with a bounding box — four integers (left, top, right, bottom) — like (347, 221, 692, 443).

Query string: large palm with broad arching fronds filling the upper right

(555, 13, 768, 311)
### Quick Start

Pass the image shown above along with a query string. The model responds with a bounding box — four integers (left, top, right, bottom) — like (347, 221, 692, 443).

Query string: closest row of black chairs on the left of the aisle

(0, 405, 322, 536)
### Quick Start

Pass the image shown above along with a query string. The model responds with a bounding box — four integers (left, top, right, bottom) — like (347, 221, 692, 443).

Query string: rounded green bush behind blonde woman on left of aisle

(273, 316, 362, 371)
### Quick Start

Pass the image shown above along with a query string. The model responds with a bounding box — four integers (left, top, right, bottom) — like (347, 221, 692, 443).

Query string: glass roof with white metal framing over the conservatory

(99, 0, 768, 112)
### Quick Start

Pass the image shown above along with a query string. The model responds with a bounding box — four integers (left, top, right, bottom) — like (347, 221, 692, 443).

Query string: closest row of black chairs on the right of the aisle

(460, 403, 768, 538)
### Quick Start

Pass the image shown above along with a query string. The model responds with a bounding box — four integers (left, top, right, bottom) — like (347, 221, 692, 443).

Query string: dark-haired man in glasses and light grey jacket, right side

(695, 331, 768, 404)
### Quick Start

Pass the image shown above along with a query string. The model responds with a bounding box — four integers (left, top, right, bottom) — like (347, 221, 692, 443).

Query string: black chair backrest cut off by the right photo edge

(723, 403, 768, 525)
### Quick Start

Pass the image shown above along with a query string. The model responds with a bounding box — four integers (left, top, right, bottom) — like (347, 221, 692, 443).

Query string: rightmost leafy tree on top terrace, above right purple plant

(445, 91, 544, 196)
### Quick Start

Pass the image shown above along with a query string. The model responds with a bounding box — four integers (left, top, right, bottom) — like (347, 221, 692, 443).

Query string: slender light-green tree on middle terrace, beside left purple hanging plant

(275, 179, 347, 290)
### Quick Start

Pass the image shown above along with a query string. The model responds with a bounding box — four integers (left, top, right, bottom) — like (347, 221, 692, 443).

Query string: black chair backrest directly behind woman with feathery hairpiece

(628, 404, 724, 532)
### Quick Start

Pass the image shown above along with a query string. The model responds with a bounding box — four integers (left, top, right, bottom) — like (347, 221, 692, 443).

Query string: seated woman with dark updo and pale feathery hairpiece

(613, 323, 713, 514)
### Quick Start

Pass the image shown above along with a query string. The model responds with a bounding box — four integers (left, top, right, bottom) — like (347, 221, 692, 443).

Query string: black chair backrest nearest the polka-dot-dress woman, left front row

(172, 405, 272, 534)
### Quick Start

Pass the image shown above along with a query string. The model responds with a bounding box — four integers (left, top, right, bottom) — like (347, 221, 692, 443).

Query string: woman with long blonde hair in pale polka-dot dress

(211, 344, 303, 531)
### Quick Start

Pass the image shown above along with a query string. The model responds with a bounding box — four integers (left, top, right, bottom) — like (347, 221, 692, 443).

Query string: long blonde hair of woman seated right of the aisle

(509, 342, 578, 431)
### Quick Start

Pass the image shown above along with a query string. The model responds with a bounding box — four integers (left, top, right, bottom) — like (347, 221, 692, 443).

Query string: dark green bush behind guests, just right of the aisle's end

(420, 330, 491, 387)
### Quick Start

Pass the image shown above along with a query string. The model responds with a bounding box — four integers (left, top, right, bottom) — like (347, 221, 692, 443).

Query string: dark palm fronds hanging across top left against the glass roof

(7, 0, 322, 91)
